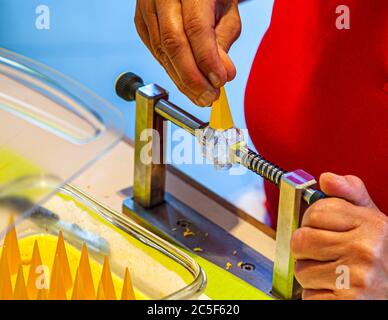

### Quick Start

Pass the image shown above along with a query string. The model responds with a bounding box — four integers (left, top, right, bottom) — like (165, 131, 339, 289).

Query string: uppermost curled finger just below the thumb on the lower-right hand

(302, 198, 365, 232)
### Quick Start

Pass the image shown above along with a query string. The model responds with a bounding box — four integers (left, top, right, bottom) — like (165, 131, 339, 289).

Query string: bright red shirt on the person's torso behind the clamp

(245, 0, 388, 226)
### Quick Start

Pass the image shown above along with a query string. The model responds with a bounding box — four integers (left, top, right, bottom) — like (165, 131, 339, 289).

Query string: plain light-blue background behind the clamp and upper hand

(0, 0, 273, 220)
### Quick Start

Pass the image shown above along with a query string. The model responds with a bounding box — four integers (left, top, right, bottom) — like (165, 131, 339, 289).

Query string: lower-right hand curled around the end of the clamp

(291, 173, 388, 299)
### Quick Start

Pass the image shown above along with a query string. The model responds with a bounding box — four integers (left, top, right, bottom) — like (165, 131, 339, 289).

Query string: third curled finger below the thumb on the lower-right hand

(295, 260, 338, 290)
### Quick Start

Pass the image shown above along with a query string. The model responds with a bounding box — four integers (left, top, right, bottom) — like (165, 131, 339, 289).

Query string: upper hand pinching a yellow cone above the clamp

(135, 0, 241, 106)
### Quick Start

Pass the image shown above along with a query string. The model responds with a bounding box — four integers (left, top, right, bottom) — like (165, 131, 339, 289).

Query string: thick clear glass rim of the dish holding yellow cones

(61, 184, 207, 300)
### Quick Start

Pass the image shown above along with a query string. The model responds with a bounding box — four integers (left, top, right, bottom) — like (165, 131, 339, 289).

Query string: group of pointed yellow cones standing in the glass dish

(0, 217, 135, 300)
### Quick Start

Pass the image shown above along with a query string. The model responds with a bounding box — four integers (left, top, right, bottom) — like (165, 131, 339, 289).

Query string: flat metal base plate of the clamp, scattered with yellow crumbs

(123, 193, 273, 295)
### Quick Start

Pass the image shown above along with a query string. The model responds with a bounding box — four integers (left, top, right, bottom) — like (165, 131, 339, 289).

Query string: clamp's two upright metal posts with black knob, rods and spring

(116, 73, 325, 299)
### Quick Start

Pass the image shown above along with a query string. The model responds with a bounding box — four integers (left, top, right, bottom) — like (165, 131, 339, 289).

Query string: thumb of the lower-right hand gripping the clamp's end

(319, 173, 377, 208)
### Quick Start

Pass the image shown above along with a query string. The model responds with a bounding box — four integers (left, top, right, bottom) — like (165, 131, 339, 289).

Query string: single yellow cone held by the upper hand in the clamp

(209, 87, 234, 131)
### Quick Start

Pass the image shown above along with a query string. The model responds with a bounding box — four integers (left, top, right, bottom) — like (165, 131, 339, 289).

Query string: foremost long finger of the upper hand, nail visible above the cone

(182, 0, 227, 88)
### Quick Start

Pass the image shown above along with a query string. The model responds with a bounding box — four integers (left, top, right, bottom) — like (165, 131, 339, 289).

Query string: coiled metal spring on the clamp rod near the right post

(243, 150, 286, 185)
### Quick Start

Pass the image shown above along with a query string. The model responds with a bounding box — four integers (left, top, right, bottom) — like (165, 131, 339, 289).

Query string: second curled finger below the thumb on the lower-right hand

(291, 227, 343, 261)
